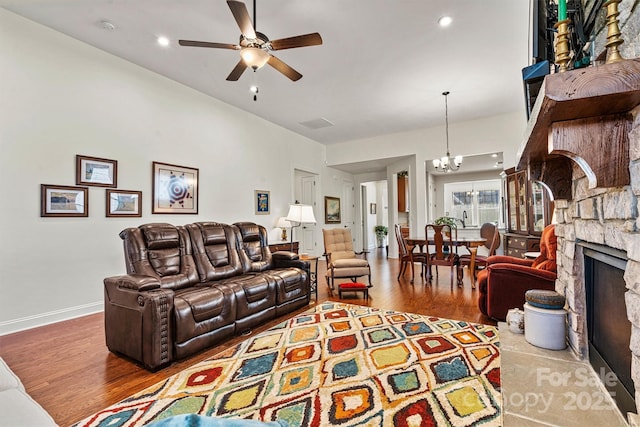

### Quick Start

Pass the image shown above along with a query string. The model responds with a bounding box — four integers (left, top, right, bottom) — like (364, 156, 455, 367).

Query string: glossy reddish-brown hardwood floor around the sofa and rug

(0, 249, 496, 426)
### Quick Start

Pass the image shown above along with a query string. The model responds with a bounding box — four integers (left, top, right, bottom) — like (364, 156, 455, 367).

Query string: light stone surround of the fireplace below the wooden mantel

(555, 108, 640, 412)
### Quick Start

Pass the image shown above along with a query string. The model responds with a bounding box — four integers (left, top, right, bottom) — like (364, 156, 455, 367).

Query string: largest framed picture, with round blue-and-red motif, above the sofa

(151, 162, 199, 214)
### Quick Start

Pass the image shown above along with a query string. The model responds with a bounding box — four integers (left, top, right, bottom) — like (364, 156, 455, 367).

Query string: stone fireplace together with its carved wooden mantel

(518, 53, 640, 422)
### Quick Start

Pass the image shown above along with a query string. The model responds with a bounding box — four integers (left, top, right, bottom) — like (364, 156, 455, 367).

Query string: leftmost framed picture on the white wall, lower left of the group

(40, 184, 89, 217)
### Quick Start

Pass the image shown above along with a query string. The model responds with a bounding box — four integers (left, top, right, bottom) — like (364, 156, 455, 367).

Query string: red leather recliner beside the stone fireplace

(478, 224, 558, 320)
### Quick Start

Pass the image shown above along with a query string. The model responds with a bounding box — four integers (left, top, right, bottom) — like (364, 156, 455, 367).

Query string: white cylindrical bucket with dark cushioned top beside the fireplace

(524, 303, 567, 350)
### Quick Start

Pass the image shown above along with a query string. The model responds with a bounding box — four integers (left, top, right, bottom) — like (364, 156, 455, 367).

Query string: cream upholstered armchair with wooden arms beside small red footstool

(322, 228, 371, 290)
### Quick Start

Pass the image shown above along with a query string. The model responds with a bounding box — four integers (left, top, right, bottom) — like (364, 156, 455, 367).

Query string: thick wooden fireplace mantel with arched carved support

(517, 58, 640, 200)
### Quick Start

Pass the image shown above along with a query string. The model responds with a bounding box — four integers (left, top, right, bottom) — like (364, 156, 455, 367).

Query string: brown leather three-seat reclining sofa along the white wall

(104, 222, 311, 370)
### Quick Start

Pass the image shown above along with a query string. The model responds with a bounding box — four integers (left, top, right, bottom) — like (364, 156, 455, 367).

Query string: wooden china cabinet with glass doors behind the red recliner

(504, 168, 552, 258)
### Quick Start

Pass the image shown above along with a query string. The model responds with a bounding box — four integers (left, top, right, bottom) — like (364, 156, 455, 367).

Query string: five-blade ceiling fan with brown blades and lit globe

(178, 0, 322, 82)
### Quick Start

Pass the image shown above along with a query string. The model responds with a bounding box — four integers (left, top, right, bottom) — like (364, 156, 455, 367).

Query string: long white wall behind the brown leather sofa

(0, 9, 330, 334)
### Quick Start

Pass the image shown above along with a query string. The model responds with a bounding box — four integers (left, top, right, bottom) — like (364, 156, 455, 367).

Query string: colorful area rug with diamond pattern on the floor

(76, 302, 502, 427)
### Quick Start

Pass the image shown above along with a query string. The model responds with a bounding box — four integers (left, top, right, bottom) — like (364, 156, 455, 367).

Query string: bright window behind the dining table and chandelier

(444, 179, 504, 227)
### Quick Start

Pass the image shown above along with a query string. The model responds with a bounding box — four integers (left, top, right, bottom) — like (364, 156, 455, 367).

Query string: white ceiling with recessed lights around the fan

(0, 0, 529, 172)
